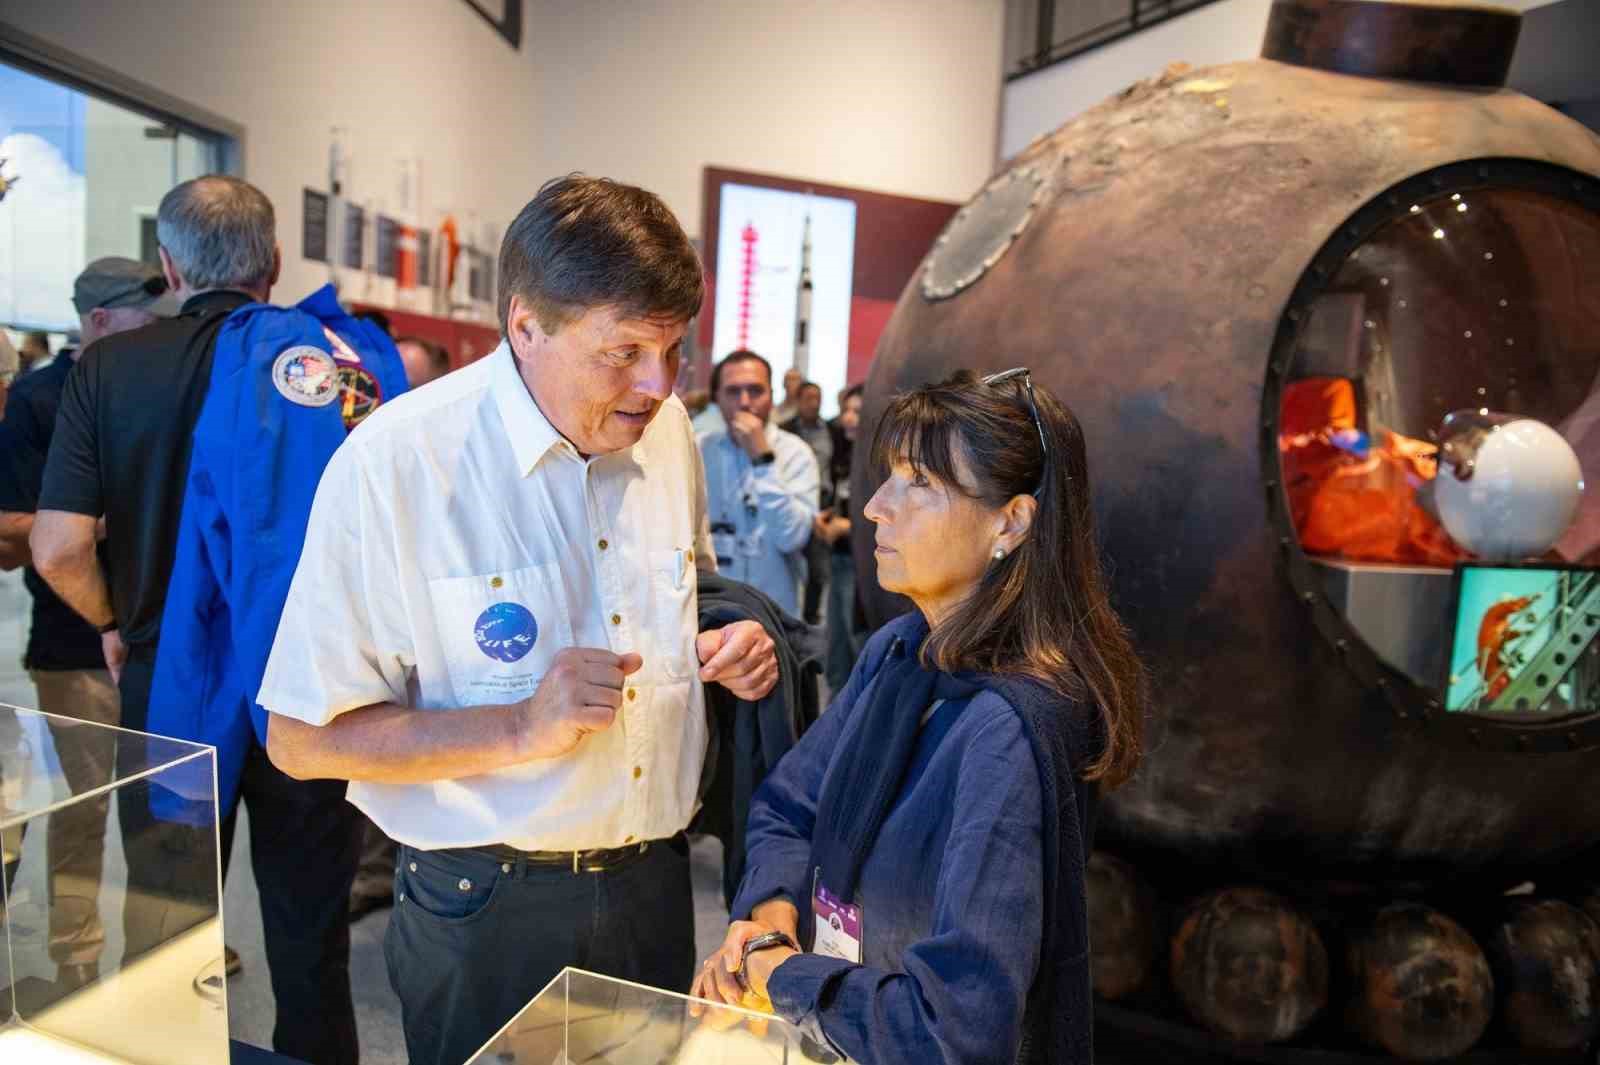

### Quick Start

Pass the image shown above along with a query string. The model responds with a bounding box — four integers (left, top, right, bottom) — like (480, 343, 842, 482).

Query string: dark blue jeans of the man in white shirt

(384, 833, 694, 1065)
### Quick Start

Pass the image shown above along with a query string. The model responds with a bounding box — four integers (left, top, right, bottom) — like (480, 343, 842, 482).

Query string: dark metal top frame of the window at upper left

(0, 21, 245, 178)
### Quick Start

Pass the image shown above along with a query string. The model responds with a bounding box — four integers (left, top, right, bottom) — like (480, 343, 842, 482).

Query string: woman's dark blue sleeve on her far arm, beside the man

(730, 627, 894, 924)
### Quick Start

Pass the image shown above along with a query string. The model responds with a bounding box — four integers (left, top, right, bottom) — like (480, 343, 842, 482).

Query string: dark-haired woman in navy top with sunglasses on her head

(693, 369, 1144, 1065)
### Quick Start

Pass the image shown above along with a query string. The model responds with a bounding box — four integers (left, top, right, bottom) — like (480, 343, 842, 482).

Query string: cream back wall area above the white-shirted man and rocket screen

(528, 0, 1003, 233)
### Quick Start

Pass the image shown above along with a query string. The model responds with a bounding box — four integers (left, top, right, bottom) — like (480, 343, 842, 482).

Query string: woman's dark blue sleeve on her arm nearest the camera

(766, 700, 1043, 1065)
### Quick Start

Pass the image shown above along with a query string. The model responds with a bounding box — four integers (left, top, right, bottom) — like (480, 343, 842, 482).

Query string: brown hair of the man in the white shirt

(499, 174, 706, 336)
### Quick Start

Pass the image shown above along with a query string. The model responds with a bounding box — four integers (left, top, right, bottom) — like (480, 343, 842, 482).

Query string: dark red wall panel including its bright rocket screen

(694, 166, 960, 417)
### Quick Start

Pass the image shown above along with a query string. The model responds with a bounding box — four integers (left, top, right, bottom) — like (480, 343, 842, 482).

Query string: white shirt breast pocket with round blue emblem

(427, 564, 573, 707)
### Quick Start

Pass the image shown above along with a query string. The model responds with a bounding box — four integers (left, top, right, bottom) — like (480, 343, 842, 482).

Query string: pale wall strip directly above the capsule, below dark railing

(1000, 0, 1272, 158)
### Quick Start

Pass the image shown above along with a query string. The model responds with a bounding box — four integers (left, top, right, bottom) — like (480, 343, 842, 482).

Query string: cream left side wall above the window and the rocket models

(0, 0, 547, 301)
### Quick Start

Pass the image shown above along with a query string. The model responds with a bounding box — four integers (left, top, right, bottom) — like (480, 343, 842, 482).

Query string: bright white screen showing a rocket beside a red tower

(712, 182, 856, 417)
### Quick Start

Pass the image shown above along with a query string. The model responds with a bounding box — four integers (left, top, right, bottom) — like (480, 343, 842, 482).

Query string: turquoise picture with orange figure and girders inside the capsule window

(1445, 563, 1600, 713)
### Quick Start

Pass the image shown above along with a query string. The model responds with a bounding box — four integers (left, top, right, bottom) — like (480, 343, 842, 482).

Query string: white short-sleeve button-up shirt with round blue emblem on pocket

(259, 342, 710, 851)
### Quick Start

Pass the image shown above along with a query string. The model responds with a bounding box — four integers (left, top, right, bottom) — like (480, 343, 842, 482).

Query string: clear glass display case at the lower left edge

(0, 705, 229, 1065)
